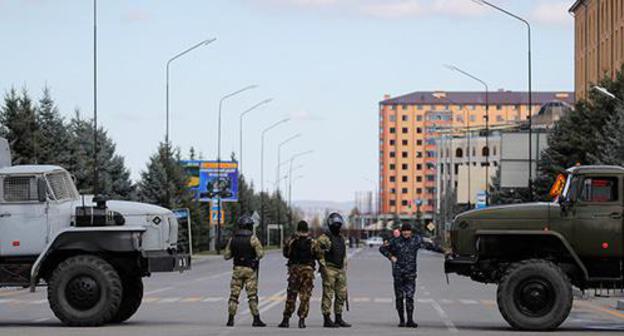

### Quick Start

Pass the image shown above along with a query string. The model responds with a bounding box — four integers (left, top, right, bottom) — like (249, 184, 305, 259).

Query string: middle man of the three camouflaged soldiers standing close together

(279, 221, 322, 329)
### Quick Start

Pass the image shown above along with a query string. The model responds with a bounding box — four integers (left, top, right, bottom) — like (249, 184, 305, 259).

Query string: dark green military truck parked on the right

(445, 166, 624, 330)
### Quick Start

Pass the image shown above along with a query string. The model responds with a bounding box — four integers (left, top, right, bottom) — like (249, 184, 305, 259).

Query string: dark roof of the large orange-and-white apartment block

(380, 91, 575, 105)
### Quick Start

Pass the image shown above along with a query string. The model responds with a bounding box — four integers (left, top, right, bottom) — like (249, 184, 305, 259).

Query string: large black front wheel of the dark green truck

(496, 259, 573, 331)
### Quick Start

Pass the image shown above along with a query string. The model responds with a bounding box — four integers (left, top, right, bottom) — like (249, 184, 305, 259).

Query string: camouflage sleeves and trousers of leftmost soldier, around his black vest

(223, 232, 264, 316)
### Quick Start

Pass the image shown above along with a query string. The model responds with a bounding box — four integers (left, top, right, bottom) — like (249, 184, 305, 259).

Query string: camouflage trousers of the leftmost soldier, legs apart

(228, 266, 258, 316)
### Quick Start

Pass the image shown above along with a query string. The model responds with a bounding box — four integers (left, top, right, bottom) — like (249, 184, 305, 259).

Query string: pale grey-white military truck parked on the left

(0, 138, 190, 326)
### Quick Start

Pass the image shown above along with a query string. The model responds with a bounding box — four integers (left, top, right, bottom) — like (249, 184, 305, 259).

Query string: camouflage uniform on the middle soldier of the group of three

(284, 233, 322, 319)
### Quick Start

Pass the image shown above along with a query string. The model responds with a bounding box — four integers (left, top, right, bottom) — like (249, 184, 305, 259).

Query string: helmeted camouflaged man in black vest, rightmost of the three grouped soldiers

(318, 213, 351, 328)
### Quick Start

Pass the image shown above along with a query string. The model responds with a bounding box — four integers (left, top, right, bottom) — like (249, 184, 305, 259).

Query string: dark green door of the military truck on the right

(573, 175, 624, 278)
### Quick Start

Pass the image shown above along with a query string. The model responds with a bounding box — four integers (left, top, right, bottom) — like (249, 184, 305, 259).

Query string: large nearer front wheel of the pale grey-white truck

(48, 255, 122, 326)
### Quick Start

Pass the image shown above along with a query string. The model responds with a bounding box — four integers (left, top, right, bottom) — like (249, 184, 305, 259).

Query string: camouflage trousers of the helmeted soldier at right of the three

(321, 266, 347, 315)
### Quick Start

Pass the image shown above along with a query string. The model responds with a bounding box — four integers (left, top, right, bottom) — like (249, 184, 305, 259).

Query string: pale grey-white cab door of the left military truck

(0, 175, 48, 257)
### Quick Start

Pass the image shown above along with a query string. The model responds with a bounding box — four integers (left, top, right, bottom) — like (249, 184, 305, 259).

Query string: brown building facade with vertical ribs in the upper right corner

(570, 0, 624, 99)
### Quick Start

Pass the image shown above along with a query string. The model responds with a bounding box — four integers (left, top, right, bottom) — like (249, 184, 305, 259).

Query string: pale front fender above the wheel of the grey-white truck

(30, 226, 146, 292)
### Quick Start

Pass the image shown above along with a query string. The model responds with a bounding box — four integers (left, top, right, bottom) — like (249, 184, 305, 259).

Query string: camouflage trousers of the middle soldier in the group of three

(284, 265, 314, 319)
